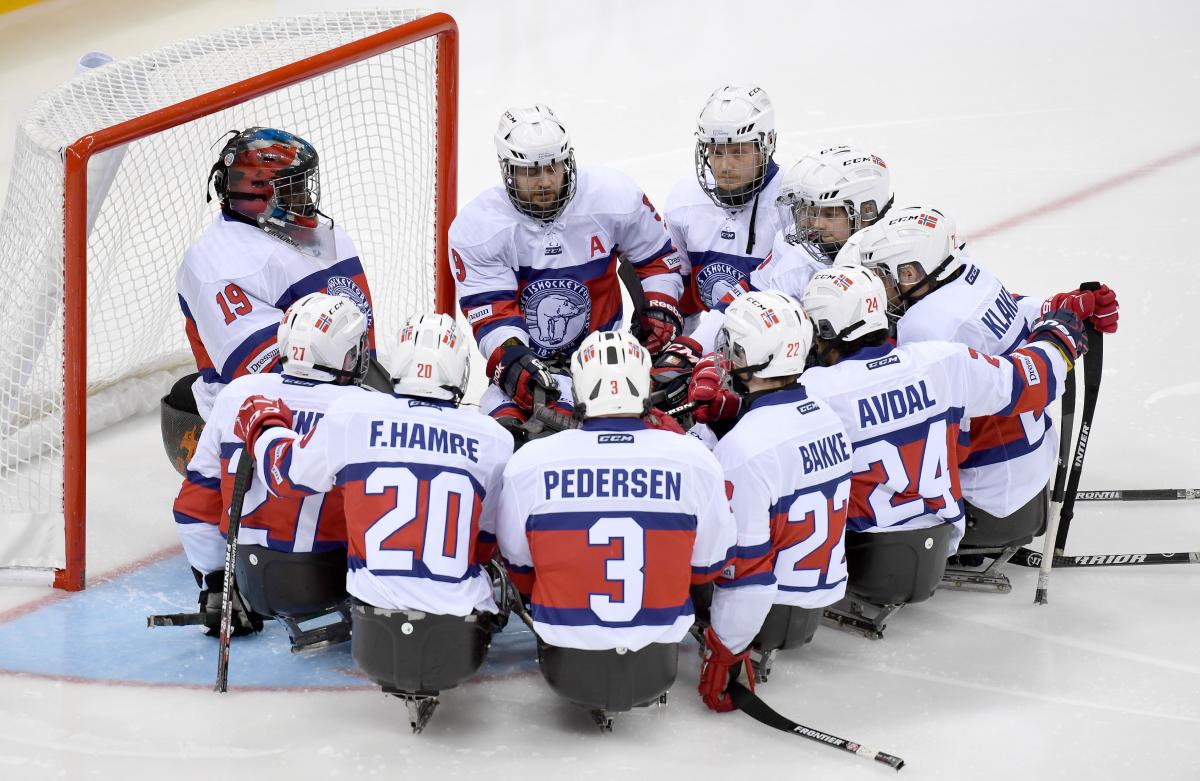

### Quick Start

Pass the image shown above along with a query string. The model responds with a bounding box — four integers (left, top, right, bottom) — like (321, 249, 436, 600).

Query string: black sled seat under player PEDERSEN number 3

(538, 643, 679, 713)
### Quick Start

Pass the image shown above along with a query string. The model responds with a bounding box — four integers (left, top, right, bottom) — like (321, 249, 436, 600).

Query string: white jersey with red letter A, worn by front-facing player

(450, 167, 683, 360)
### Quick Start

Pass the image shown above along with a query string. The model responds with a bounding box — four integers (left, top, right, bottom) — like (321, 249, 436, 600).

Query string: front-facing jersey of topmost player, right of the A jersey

(664, 161, 782, 316)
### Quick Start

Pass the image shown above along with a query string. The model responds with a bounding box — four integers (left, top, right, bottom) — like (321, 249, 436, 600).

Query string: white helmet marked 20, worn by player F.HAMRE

(391, 314, 470, 403)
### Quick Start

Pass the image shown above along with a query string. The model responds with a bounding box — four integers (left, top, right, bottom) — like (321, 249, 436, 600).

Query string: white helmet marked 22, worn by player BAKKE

(716, 290, 812, 380)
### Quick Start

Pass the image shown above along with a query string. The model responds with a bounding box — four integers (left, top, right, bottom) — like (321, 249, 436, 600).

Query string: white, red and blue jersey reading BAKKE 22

(713, 385, 852, 628)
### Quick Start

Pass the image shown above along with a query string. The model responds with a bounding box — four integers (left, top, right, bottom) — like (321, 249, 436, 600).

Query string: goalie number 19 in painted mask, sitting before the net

(162, 127, 374, 475)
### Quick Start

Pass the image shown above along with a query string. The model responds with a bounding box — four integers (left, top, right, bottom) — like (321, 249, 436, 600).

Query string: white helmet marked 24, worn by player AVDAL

(800, 264, 889, 342)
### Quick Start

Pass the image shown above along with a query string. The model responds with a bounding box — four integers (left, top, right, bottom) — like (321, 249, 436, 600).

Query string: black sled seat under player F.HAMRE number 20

(350, 599, 492, 695)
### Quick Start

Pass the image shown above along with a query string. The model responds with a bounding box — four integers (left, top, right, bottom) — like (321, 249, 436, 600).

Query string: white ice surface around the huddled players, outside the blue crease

(0, 0, 1200, 781)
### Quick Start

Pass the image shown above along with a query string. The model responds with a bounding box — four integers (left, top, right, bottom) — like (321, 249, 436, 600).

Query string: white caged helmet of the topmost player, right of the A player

(696, 84, 775, 208)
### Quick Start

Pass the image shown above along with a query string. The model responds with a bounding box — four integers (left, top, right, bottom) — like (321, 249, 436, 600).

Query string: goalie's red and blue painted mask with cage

(209, 127, 335, 258)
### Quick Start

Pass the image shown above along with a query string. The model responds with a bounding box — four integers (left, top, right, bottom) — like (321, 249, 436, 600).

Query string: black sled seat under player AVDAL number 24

(846, 523, 952, 605)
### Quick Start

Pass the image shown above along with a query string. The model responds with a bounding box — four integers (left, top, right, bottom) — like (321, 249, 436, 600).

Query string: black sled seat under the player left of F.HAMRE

(234, 545, 346, 619)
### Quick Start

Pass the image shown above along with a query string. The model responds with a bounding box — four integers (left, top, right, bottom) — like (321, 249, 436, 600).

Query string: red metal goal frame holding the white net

(54, 13, 458, 591)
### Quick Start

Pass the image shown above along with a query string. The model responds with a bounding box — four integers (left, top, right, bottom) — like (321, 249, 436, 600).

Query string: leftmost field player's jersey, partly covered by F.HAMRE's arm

(174, 373, 368, 573)
